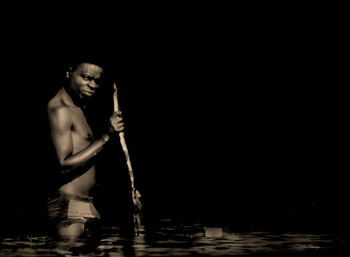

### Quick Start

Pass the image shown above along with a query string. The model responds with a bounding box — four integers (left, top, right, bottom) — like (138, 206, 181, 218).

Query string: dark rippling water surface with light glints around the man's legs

(0, 220, 344, 257)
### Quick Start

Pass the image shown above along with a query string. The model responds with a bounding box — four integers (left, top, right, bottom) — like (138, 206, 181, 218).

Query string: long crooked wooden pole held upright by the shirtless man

(113, 83, 142, 235)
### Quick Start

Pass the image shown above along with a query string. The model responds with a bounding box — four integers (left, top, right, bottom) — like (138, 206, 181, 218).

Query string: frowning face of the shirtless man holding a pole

(70, 63, 103, 99)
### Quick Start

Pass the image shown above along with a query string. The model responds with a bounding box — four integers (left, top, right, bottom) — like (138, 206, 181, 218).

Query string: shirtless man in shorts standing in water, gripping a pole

(47, 57, 124, 238)
